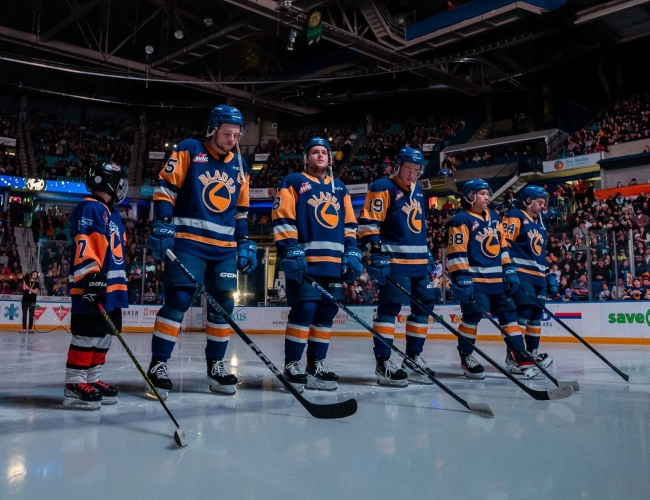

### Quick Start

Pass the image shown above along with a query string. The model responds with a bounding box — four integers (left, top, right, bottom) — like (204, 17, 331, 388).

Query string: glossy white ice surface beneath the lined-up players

(0, 332, 650, 500)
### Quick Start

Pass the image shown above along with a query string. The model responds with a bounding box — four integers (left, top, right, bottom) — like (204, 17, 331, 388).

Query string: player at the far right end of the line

(501, 186, 560, 374)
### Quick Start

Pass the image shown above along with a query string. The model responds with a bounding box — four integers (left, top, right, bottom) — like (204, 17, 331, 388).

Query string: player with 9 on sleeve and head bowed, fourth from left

(359, 146, 435, 387)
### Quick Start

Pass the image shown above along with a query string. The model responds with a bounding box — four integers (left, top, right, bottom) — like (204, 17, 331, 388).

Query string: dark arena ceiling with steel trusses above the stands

(0, 0, 650, 115)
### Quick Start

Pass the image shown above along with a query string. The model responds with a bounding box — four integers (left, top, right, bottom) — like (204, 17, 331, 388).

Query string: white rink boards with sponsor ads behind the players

(0, 296, 650, 344)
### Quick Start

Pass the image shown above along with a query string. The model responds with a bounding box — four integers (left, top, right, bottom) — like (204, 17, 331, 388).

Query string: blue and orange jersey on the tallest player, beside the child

(153, 139, 249, 260)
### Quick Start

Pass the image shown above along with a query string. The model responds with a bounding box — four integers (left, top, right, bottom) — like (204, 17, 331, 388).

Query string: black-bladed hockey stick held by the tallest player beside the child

(166, 249, 357, 419)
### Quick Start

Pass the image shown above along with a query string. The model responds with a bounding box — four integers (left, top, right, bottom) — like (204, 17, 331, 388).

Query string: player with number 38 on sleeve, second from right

(447, 179, 539, 379)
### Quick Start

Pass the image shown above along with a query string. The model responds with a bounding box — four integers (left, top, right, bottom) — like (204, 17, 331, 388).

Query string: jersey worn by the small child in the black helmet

(69, 198, 129, 314)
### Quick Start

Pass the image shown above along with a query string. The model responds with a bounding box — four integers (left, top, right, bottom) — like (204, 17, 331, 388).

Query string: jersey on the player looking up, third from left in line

(272, 173, 357, 277)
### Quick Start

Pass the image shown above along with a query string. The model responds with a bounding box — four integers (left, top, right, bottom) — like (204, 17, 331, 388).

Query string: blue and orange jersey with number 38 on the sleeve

(447, 209, 511, 294)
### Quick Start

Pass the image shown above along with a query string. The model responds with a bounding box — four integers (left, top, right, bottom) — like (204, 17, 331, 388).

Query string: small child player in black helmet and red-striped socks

(63, 161, 129, 410)
